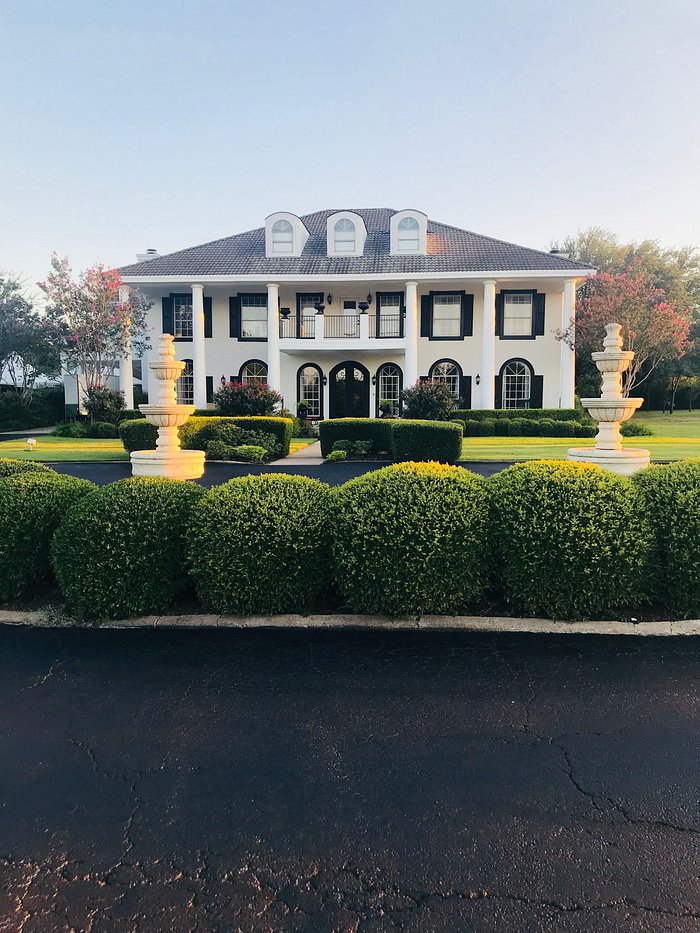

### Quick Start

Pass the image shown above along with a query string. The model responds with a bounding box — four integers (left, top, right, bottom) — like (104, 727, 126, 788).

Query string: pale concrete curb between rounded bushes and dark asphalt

(0, 609, 700, 637)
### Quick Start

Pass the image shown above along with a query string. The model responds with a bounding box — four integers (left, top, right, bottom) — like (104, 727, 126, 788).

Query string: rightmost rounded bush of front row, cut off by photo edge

(633, 460, 700, 618)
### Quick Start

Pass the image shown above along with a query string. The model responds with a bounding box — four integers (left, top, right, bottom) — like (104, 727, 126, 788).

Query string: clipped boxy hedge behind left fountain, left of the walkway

(119, 415, 294, 457)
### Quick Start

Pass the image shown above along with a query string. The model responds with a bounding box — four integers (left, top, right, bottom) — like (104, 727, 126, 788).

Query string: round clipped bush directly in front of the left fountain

(51, 477, 204, 618)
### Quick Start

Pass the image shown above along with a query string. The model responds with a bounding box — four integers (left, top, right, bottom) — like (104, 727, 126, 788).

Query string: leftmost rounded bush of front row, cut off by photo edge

(0, 470, 95, 599)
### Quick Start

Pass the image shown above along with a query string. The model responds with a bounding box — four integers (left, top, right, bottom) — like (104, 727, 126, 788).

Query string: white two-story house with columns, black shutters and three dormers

(87, 208, 594, 418)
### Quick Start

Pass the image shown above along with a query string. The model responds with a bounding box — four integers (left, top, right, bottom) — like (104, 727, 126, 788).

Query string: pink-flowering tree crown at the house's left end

(37, 253, 152, 395)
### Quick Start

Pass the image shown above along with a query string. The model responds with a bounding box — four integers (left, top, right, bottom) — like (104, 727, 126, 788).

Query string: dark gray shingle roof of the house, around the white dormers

(119, 208, 590, 276)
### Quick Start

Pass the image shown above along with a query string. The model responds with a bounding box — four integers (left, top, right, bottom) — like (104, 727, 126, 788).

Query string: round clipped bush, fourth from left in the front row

(332, 463, 488, 615)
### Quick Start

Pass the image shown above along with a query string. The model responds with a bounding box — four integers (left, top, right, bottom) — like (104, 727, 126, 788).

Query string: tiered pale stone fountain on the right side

(569, 324, 650, 476)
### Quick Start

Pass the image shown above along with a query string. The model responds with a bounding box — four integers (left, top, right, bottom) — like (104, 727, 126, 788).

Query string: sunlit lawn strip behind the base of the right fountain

(462, 436, 700, 460)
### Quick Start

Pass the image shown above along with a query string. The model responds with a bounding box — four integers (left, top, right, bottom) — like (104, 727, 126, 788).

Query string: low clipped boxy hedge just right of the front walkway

(319, 418, 463, 463)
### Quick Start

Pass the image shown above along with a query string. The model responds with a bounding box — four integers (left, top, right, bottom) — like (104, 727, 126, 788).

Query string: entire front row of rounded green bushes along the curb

(0, 461, 700, 618)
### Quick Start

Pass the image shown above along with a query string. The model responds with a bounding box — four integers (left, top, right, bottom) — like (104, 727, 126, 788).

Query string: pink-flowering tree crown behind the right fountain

(559, 261, 691, 395)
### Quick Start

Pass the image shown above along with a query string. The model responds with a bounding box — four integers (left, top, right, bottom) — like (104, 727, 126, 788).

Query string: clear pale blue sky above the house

(0, 0, 700, 292)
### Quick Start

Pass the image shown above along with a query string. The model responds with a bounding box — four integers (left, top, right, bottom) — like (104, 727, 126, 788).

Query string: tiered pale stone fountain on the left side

(131, 334, 204, 479)
